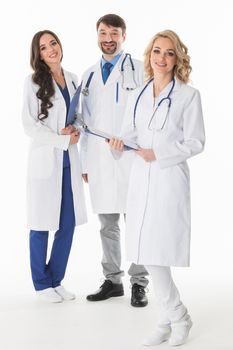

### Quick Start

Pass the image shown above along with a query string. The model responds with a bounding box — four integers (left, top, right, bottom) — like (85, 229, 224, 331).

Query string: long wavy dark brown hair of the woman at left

(30, 29, 63, 120)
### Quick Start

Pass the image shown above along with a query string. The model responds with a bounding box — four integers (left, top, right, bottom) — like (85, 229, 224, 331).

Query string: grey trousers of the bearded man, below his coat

(98, 214, 149, 287)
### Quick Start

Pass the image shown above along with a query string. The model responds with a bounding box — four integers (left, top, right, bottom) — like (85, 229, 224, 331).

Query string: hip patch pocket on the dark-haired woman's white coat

(28, 145, 54, 179)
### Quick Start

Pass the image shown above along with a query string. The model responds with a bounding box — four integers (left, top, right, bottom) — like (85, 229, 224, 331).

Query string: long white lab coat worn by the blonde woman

(123, 80, 205, 266)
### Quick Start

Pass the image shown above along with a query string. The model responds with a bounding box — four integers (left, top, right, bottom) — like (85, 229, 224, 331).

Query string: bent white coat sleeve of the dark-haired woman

(22, 76, 70, 150)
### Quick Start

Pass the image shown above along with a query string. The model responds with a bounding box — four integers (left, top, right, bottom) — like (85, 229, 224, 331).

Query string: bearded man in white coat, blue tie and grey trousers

(81, 14, 148, 307)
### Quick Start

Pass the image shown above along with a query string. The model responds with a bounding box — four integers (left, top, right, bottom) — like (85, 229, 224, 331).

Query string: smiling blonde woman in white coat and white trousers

(110, 30, 205, 346)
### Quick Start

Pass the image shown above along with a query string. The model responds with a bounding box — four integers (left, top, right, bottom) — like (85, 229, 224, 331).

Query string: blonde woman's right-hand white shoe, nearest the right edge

(169, 317, 193, 346)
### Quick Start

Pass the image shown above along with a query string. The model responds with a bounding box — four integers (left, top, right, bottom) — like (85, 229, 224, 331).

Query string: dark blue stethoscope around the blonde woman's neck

(133, 77, 175, 130)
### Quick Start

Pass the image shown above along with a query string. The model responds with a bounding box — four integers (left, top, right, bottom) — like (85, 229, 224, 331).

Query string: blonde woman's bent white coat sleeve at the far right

(154, 90, 205, 168)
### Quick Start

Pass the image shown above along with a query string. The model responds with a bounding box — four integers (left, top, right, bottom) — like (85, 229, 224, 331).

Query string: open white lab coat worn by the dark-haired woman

(22, 71, 87, 231)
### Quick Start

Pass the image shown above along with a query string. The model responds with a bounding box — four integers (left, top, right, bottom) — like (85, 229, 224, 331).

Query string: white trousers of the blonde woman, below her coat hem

(145, 266, 189, 327)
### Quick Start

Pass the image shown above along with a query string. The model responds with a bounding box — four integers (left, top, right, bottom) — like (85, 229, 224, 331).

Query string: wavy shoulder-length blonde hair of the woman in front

(144, 30, 192, 84)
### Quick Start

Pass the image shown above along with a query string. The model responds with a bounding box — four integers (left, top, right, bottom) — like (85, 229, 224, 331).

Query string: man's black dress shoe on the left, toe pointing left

(87, 280, 124, 301)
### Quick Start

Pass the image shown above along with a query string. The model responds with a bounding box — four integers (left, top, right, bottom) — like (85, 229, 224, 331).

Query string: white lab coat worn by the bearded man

(81, 54, 143, 214)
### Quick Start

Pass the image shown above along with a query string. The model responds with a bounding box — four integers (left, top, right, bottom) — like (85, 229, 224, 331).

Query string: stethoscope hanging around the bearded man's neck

(82, 53, 137, 96)
